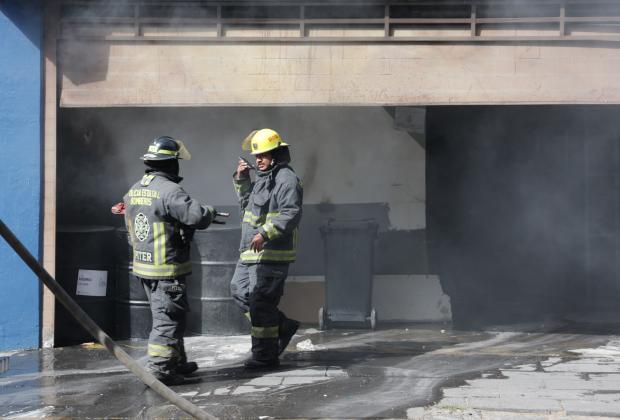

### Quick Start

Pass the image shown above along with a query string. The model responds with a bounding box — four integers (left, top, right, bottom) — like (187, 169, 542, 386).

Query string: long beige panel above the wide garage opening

(60, 40, 620, 107)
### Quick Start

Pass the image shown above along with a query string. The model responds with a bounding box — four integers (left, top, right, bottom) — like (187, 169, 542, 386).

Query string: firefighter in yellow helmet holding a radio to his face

(231, 128, 303, 369)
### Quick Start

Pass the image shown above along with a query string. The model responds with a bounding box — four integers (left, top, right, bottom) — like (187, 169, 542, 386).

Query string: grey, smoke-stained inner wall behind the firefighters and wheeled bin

(58, 107, 450, 322)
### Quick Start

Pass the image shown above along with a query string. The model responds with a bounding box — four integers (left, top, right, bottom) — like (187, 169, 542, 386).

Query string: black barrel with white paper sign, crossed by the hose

(54, 226, 114, 346)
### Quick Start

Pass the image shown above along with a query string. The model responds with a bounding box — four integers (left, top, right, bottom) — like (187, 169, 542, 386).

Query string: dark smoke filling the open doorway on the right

(427, 107, 620, 325)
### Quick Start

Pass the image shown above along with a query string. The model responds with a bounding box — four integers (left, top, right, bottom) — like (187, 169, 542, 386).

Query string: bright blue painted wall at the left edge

(0, 0, 43, 350)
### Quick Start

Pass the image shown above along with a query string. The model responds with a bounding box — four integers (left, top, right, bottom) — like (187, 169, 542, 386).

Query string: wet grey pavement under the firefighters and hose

(0, 324, 620, 420)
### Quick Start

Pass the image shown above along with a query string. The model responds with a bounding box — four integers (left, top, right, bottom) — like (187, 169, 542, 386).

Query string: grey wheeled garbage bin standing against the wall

(319, 219, 378, 330)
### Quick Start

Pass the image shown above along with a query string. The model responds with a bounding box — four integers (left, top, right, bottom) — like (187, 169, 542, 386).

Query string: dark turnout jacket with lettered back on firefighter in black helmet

(123, 171, 215, 280)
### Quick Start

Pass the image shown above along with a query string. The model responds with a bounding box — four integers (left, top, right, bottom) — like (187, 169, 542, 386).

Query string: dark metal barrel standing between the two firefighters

(187, 227, 249, 335)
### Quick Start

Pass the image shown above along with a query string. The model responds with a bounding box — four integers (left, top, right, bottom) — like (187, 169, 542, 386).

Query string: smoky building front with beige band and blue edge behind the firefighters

(0, 0, 620, 348)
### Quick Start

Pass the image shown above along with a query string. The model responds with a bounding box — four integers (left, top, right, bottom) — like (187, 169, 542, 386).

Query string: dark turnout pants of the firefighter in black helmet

(140, 278, 189, 375)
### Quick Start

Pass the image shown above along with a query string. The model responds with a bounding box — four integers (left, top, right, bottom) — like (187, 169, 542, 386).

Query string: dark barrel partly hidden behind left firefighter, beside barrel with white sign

(114, 228, 153, 338)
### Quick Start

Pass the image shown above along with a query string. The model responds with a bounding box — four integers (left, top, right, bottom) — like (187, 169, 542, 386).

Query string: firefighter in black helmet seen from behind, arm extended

(123, 136, 216, 385)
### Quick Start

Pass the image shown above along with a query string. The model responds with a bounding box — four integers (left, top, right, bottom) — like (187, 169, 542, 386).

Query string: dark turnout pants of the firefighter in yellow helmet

(230, 261, 288, 361)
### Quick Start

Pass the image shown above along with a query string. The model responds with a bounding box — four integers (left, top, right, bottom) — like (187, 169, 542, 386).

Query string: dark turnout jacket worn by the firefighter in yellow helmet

(233, 164, 303, 263)
